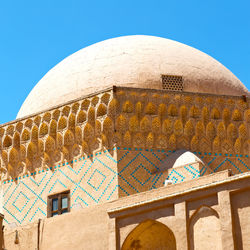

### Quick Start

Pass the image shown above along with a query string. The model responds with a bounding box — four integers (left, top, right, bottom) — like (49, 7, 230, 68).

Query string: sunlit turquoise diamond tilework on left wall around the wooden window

(3, 153, 117, 224)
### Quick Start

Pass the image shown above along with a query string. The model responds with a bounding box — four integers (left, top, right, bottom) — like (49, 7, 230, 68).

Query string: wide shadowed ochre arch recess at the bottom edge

(121, 220, 176, 250)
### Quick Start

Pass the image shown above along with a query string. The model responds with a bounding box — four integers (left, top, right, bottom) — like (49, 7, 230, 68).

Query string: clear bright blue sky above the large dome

(0, 0, 250, 124)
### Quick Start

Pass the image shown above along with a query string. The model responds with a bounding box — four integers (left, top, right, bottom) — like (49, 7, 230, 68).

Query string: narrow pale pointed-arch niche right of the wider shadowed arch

(188, 205, 222, 250)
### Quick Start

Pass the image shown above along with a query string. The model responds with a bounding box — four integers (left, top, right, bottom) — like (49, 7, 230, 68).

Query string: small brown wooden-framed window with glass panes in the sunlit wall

(47, 190, 70, 217)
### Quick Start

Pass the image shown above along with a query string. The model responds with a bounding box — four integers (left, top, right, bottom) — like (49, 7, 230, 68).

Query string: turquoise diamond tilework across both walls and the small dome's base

(3, 148, 250, 224)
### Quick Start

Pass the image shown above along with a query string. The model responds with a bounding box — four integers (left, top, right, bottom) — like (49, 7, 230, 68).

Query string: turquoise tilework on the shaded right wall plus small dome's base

(117, 148, 250, 197)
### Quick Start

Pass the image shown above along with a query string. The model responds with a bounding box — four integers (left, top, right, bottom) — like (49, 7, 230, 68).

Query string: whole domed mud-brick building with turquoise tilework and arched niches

(0, 36, 250, 250)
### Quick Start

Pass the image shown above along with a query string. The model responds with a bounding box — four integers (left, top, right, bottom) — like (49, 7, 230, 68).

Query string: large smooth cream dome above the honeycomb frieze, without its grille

(17, 35, 248, 118)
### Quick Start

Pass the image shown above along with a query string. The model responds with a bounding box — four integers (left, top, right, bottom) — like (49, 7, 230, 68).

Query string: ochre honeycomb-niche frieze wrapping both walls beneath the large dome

(0, 87, 250, 179)
